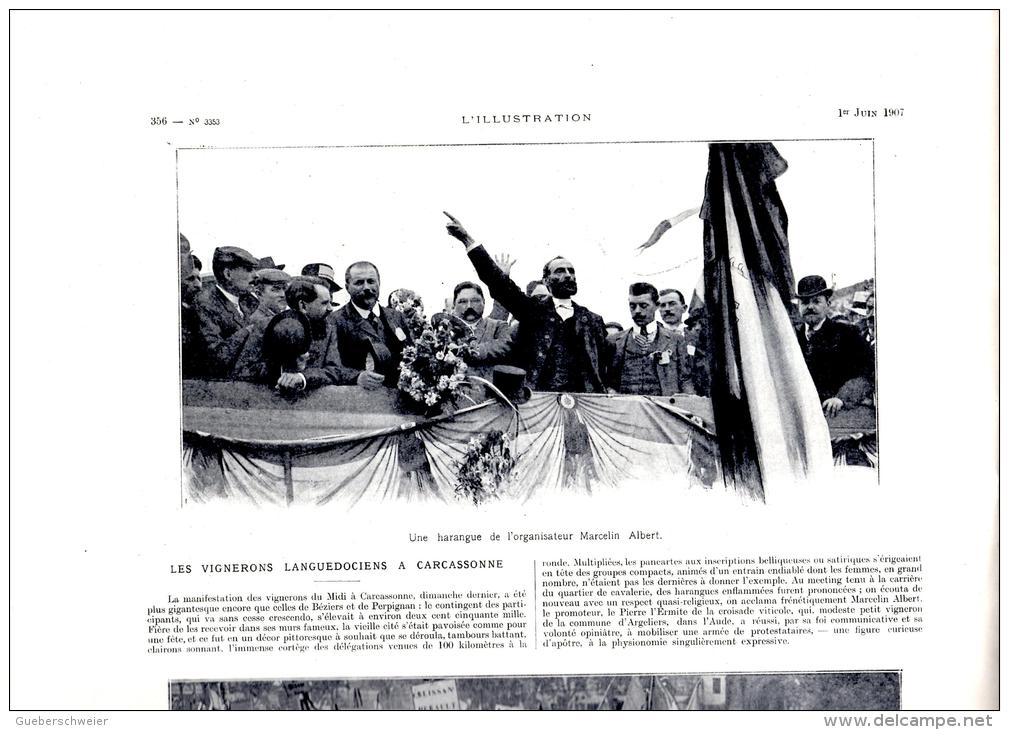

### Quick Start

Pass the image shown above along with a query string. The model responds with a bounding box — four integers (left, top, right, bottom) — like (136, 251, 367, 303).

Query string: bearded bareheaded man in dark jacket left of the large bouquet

(331, 262, 414, 390)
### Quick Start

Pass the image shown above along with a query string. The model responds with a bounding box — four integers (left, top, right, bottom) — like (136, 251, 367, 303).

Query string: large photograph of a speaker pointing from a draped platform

(178, 139, 879, 508)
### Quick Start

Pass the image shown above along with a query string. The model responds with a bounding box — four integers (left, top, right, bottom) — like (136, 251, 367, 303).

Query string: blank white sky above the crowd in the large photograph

(179, 140, 874, 323)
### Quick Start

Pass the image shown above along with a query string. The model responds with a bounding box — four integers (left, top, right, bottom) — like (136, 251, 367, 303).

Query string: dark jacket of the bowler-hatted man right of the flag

(795, 319, 876, 406)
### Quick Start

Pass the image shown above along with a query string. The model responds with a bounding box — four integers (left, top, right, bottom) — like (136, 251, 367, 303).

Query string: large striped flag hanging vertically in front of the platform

(701, 143, 831, 500)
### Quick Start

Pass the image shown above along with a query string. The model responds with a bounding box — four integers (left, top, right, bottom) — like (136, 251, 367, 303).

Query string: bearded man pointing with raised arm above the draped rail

(446, 213, 608, 393)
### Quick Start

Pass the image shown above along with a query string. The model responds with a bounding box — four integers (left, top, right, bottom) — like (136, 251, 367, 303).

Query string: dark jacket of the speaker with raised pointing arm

(469, 246, 608, 393)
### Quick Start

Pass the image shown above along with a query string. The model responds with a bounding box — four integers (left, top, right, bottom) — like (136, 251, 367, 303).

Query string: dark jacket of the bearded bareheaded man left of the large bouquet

(330, 303, 414, 388)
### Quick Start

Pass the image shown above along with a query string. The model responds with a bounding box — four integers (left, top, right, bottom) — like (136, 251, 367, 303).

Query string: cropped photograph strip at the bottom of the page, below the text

(170, 670, 901, 711)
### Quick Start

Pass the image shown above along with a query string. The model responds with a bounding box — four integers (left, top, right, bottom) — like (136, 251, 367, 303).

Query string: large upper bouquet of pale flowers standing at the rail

(400, 319, 466, 409)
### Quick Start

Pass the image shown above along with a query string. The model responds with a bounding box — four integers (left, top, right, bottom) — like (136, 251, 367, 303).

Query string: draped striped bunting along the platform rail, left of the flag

(183, 382, 717, 506)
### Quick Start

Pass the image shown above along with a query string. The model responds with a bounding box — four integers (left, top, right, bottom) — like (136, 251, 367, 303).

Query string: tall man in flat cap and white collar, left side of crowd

(190, 246, 259, 380)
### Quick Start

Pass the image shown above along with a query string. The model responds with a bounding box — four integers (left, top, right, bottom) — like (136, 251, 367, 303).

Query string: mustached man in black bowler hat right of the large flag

(795, 276, 875, 416)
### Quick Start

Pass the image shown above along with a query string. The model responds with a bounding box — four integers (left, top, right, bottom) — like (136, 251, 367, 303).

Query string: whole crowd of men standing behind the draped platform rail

(180, 211, 875, 415)
